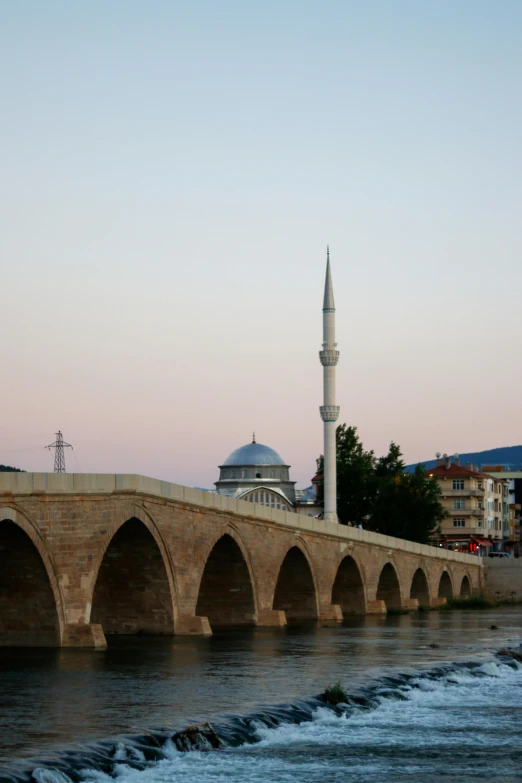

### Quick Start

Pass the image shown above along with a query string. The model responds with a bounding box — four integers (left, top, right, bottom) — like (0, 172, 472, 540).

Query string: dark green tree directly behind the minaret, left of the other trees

(317, 424, 375, 525)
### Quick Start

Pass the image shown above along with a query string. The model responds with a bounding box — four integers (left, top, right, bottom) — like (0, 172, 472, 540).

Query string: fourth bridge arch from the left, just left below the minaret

(272, 539, 319, 623)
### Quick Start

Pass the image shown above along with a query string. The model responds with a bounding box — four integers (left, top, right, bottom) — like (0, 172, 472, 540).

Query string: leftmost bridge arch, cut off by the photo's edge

(0, 506, 65, 647)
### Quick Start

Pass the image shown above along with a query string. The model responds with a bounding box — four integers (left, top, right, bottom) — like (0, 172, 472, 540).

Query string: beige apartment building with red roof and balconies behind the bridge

(426, 454, 507, 556)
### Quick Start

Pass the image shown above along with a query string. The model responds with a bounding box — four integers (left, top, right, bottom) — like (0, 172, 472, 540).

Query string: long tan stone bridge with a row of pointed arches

(0, 473, 483, 647)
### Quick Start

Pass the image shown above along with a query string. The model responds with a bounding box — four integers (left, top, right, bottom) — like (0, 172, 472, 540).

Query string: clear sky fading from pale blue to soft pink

(0, 0, 522, 486)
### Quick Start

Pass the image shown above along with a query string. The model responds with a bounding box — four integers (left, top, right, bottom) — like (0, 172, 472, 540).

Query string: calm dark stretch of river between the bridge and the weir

(0, 607, 522, 761)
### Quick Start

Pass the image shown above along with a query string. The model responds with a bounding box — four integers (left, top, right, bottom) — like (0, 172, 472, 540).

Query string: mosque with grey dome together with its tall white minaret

(210, 251, 339, 522)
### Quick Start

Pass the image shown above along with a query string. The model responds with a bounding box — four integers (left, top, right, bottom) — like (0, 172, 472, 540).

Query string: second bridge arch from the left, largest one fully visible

(91, 509, 177, 636)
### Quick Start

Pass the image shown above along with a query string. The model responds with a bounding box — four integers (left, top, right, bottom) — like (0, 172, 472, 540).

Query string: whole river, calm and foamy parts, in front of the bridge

(0, 607, 522, 783)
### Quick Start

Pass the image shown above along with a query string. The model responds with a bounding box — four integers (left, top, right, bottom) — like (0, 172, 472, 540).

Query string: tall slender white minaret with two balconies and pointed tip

(319, 247, 339, 522)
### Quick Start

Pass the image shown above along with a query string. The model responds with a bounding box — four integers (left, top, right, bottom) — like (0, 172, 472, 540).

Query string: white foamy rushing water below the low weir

(33, 660, 522, 783)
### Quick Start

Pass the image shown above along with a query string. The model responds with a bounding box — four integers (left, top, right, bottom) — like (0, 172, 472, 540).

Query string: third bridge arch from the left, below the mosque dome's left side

(196, 526, 257, 628)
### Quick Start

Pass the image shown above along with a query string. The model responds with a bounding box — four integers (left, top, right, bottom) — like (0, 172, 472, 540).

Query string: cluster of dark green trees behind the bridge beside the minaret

(317, 424, 446, 544)
